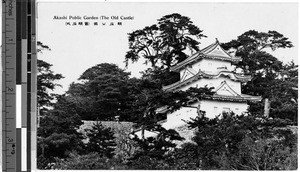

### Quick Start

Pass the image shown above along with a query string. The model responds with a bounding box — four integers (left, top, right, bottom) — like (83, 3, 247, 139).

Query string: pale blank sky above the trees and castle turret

(37, 0, 298, 94)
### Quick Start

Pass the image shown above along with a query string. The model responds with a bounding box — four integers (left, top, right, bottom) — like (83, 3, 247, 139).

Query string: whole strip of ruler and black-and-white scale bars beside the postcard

(1, 0, 37, 171)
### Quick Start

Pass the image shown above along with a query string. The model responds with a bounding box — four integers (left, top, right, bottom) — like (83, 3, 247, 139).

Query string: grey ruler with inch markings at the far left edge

(2, 0, 16, 171)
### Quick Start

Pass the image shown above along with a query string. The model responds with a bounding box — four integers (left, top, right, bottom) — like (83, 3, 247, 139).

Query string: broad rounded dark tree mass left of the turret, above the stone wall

(66, 63, 213, 124)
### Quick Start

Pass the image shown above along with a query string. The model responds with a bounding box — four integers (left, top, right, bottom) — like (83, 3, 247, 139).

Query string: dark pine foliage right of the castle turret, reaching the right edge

(222, 30, 298, 123)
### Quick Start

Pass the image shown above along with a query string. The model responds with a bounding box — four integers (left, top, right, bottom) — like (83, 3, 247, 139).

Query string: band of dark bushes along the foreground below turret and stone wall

(39, 112, 297, 170)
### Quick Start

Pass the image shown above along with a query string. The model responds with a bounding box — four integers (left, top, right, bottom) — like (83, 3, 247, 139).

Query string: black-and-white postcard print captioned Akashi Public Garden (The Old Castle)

(36, 0, 298, 170)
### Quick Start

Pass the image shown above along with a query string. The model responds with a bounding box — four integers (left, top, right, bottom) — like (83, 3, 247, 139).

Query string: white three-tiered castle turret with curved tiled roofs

(158, 40, 261, 128)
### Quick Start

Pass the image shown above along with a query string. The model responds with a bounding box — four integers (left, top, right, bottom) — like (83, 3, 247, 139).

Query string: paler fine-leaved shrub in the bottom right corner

(218, 137, 297, 170)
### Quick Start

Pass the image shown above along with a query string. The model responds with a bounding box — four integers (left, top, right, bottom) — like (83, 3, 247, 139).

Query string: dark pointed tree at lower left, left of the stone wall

(37, 96, 84, 169)
